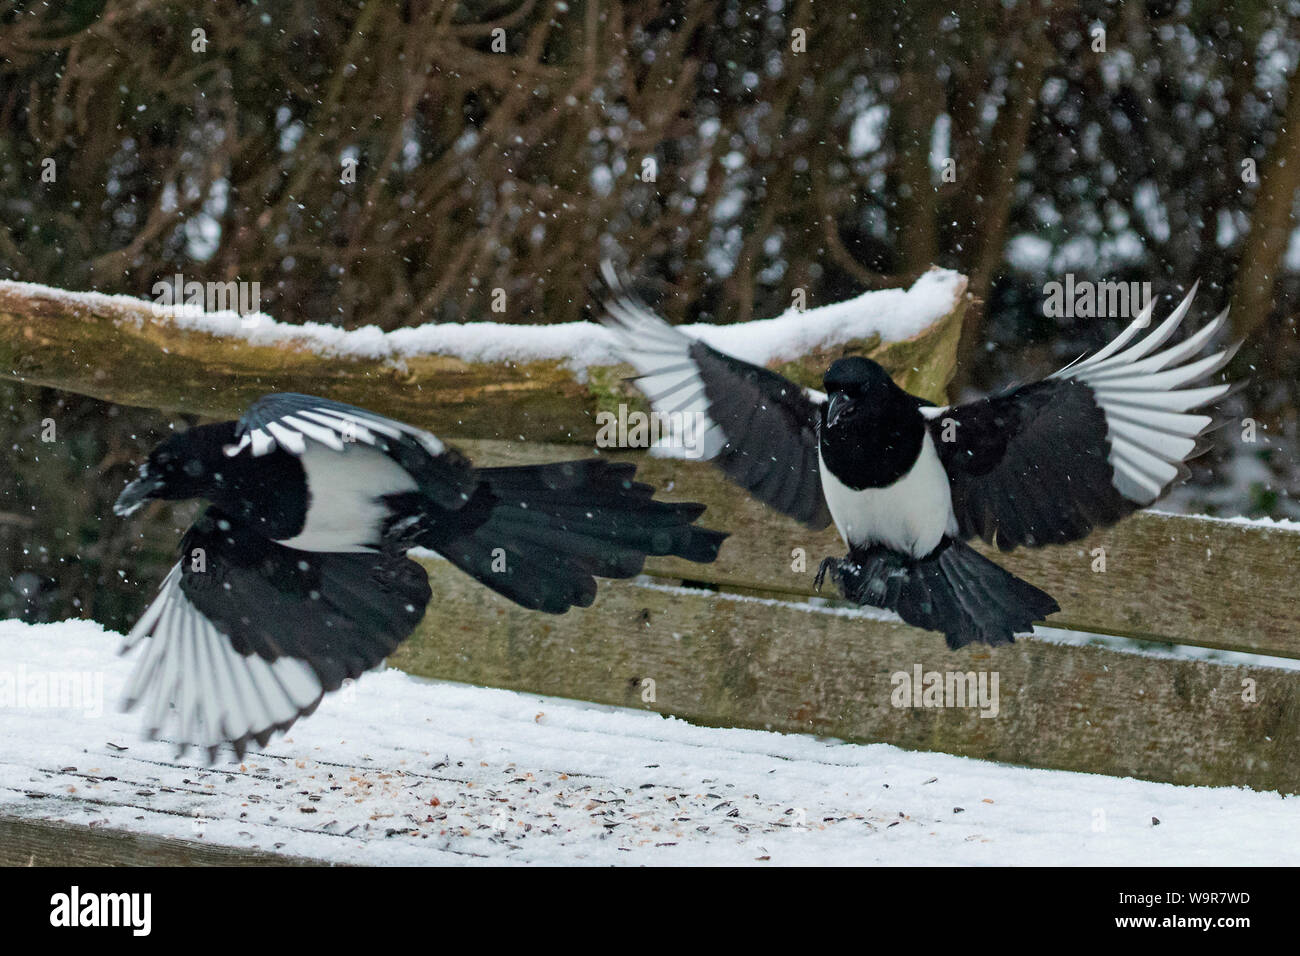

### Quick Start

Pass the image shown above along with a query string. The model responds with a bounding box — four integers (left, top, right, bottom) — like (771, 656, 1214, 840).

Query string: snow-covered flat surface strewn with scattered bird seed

(0, 622, 1300, 866)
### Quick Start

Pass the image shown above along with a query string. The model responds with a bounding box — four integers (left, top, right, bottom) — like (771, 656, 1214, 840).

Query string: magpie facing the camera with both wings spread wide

(602, 269, 1236, 648)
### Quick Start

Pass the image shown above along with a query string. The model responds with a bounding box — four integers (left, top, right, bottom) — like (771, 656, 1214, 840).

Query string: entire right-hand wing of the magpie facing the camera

(922, 286, 1236, 550)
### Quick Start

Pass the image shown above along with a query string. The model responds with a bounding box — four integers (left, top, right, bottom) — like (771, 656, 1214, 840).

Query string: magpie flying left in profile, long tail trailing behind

(113, 394, 725, 761)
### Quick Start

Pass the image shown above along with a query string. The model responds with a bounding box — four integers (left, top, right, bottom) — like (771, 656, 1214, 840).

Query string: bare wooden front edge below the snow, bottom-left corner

(0, 816, 329, 866)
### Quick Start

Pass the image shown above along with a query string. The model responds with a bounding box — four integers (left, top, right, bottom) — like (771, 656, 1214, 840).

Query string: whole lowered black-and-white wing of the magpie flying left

(122, 507, 430, 761)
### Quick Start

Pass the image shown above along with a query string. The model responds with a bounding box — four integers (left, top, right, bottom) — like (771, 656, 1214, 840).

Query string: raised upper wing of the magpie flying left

(226, 392, 478, 509)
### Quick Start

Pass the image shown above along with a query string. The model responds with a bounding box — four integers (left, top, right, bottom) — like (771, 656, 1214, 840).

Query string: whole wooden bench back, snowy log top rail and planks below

(0, 272, 1300, 860)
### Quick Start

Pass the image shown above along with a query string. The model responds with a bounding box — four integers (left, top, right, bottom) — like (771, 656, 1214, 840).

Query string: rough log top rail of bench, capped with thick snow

(0, 269, 970, 444)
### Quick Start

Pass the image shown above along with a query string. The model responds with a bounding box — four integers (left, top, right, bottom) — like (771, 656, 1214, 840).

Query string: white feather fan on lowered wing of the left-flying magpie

(122, 564, 324, 756)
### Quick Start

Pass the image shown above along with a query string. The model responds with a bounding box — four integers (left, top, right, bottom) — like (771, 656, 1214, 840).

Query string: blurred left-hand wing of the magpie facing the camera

(602, 263, 831, 528)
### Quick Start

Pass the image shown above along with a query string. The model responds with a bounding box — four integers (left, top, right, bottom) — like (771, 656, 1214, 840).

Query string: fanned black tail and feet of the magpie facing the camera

(818, 538, 1061, 648)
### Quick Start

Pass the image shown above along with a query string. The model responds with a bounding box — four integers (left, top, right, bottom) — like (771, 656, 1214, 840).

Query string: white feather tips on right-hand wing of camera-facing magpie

(1050, 285, 1236, 505)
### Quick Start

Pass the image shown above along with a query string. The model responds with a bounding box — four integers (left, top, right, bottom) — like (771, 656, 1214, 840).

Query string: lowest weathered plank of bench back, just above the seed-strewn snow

(393, 562, 1300, 792)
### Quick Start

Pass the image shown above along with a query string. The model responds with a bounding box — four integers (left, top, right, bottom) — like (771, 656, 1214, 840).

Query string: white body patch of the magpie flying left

(281, 442, 416, 551)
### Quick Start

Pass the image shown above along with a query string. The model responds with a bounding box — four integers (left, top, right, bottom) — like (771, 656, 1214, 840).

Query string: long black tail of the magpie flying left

(419, 458, 727, 614)
